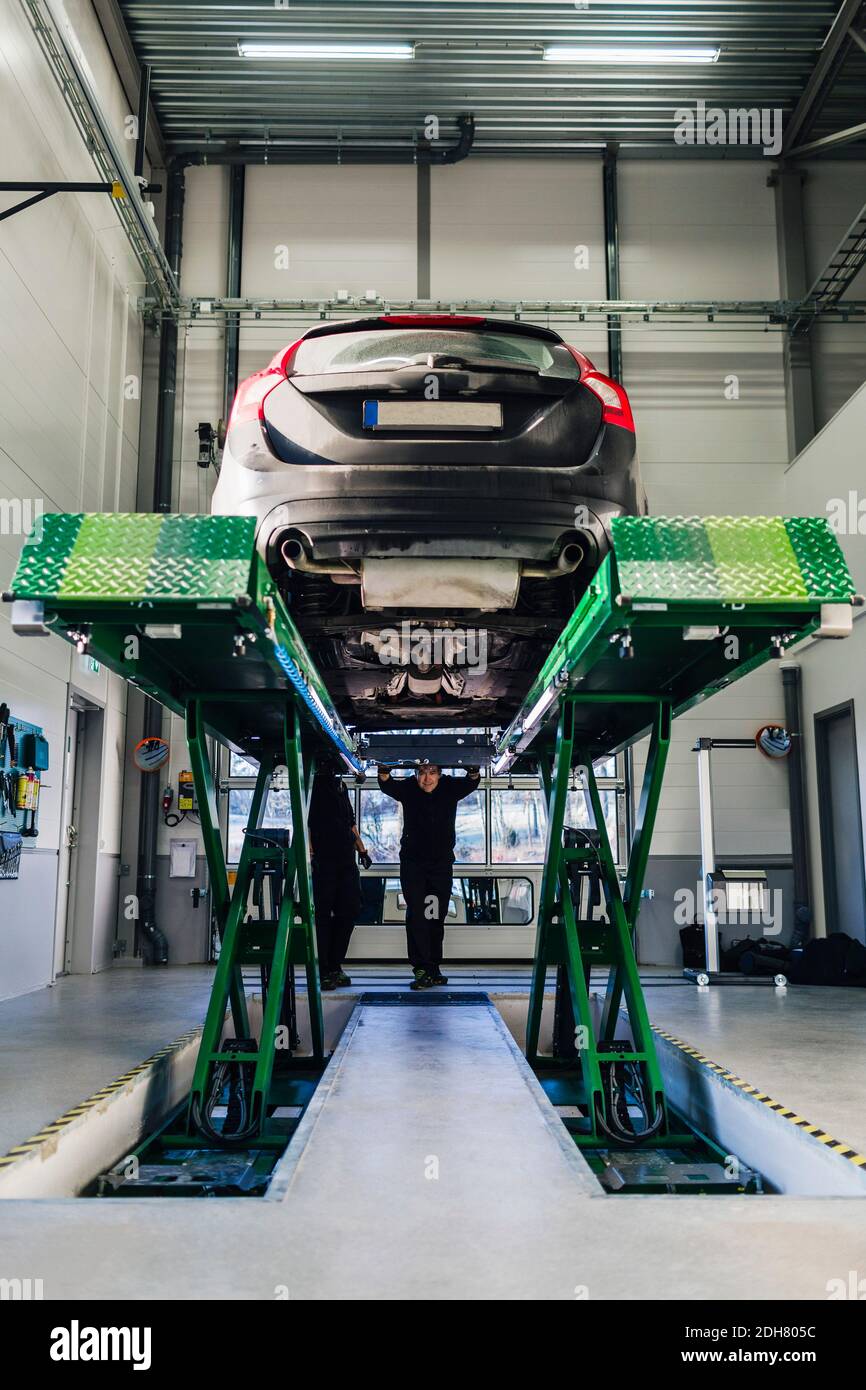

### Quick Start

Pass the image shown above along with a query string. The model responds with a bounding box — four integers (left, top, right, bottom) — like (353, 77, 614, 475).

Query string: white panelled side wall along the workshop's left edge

(0, 0, 142, 997)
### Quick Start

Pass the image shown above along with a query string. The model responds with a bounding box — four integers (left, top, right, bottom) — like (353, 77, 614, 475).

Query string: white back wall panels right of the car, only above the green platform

(619, 160, 788, 516)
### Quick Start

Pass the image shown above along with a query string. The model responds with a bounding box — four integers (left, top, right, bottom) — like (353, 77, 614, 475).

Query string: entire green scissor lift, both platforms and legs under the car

(7, 514, 855, 1189)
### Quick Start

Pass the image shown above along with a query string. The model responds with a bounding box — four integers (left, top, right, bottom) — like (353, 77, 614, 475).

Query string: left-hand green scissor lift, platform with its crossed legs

(13, 514, 361, 1173)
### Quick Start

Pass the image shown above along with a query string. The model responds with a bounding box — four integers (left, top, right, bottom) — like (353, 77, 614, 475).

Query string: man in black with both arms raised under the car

(378, 763, 481, 990)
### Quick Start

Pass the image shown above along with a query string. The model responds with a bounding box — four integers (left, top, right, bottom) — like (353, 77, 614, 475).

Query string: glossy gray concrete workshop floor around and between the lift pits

(0, 966, 866, 1301)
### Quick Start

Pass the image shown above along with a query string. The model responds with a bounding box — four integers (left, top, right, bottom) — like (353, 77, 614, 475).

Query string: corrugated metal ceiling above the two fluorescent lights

(120, 0, 866, 157)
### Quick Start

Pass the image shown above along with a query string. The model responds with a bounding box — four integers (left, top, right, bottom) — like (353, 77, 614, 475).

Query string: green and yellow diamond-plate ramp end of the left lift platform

(13, 513, 256, 600)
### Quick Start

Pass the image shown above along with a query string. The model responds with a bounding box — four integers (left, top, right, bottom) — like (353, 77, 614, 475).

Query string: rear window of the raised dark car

(292, 328, 580, 378)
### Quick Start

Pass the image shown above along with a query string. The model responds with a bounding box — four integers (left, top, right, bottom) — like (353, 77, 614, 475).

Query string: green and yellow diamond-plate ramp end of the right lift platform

(613, 517, 853, 603)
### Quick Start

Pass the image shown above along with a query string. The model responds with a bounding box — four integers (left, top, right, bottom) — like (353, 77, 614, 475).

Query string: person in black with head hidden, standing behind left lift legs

(307, 760, 367, 990)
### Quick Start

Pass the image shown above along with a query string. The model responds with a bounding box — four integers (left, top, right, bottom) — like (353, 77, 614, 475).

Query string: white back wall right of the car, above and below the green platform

(619, 160, 790, 867)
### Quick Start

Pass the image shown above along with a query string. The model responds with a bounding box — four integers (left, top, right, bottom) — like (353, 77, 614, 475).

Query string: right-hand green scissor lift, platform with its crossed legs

(495, 517, 853, 1150)
